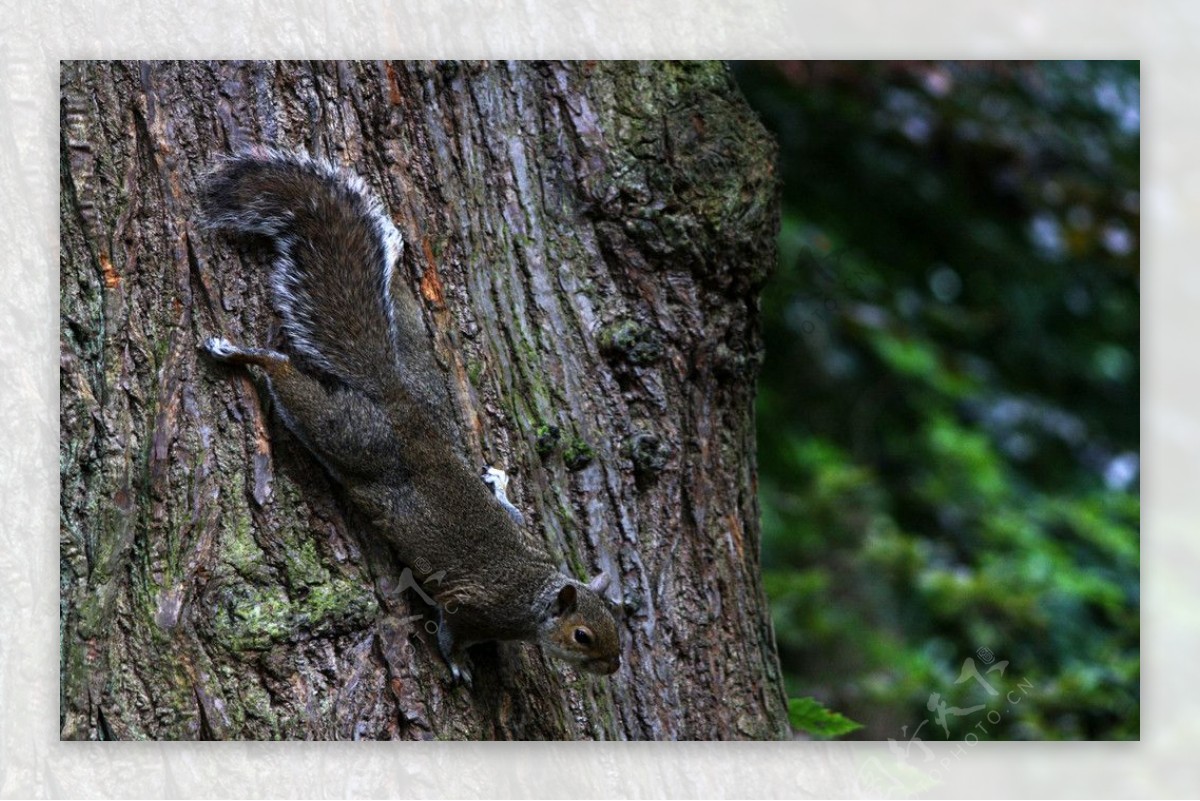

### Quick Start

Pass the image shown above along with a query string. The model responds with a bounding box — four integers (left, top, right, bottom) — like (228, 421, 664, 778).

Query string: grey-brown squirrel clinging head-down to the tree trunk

(199, 147, 620, 686)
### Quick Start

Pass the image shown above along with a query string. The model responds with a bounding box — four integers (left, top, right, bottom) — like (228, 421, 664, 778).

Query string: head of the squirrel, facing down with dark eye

(539, 573, 620, 675)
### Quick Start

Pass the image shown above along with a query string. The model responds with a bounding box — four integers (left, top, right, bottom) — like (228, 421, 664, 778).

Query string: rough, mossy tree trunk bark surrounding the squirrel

(61, 62, 788, 739)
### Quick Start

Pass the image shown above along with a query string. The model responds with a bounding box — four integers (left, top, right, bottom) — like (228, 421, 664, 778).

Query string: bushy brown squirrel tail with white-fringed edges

(199, 147, 402, 395)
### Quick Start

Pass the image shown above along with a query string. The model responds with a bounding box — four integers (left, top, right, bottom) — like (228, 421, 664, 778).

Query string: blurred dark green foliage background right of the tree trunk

(736, 62, 1140, 749)
